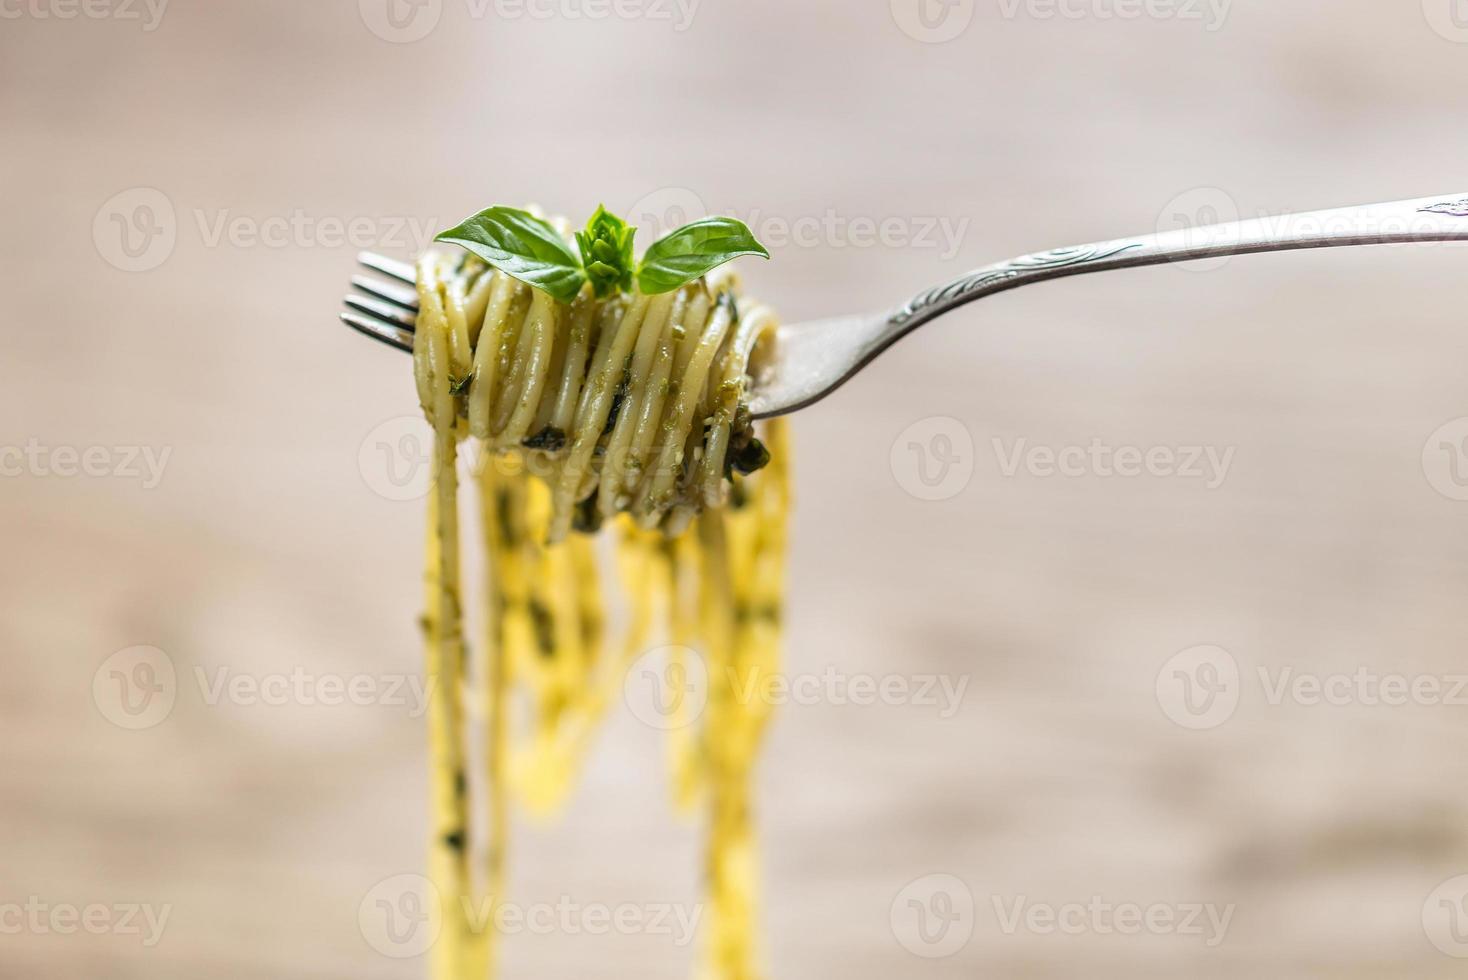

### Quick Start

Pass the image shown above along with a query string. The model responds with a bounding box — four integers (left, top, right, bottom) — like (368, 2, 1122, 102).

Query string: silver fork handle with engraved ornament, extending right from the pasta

(882, 194, 1468, 333)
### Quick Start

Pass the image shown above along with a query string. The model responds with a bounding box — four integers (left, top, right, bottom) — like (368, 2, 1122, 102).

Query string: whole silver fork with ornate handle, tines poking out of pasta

(342, 194, 1468, 418)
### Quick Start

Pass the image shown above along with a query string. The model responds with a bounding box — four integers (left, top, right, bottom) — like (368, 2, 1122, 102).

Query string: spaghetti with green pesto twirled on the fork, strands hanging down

(414, 232, 788, 980)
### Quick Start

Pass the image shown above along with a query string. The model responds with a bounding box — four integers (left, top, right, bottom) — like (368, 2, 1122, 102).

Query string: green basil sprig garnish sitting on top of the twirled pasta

(435, 207, 769, 302)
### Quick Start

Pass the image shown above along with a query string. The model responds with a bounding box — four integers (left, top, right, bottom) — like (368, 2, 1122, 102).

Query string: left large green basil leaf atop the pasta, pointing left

(433, 207, 586, 302)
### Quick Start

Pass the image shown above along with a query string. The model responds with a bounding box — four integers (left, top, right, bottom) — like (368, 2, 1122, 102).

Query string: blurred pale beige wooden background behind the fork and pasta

(0, 0, 1468, 980)
